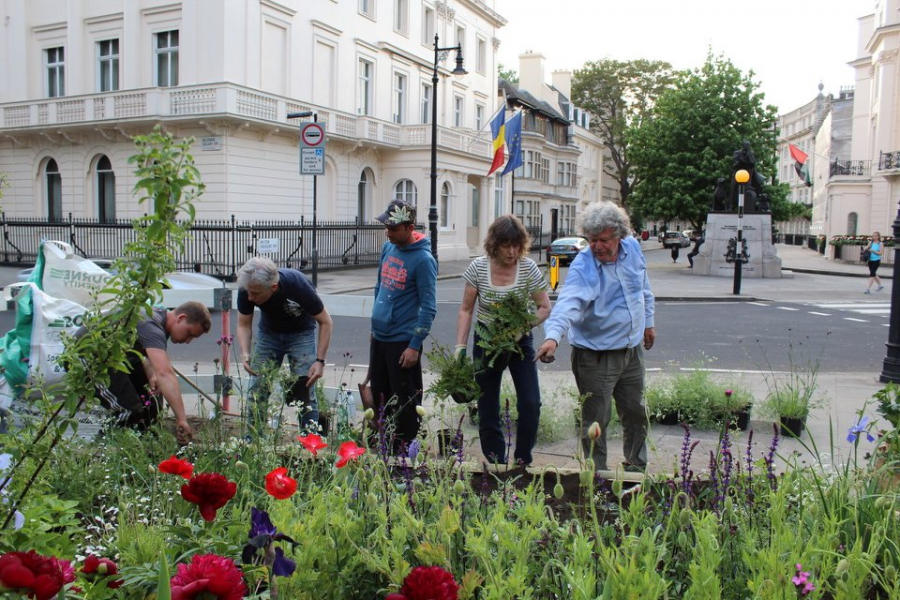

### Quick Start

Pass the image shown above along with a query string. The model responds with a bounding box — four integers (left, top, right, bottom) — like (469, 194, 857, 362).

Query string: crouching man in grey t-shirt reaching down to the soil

(96, 301, 212, 444)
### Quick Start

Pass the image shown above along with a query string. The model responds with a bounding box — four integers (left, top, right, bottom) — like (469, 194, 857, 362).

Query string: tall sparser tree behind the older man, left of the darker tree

(572, 59, 674, 212)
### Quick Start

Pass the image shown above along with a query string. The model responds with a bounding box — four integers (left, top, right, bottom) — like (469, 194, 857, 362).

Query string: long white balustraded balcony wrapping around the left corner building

(0, 84, 490, 158)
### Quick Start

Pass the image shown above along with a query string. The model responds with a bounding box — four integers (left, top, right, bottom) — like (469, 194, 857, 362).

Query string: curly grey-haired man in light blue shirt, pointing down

(537, 202, 655, 471)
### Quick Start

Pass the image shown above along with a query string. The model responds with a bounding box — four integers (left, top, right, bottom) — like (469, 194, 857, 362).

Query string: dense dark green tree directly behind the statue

(631, 53, 802, 229)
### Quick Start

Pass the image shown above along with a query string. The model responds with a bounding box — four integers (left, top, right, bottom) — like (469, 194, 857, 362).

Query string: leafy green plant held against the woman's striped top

(475, 290, 537, 367)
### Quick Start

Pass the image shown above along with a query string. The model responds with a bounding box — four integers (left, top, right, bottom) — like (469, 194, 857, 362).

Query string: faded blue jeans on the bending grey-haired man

(247, 329, 319, 432)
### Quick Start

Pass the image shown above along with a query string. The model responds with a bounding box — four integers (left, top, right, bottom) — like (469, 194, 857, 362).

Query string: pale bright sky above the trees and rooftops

(485, 0, 875, 114)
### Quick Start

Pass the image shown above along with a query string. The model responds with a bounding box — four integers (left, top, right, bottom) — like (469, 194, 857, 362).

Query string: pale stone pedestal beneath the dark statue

(693, 212, 781, 279)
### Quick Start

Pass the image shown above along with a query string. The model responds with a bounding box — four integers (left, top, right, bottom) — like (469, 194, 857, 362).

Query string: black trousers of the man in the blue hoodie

(369, 338, 423, 452)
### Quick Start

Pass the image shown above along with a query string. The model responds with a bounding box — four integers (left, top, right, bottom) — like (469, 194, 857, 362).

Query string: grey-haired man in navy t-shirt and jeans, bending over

(237, 256, 332, 431)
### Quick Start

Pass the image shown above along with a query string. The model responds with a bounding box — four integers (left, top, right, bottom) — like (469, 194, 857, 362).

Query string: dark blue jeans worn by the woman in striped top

(472, 333, 541, 465)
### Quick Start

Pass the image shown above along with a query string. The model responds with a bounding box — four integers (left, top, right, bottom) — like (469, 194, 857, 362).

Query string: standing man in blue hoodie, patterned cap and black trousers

(369, 200, 437, 451)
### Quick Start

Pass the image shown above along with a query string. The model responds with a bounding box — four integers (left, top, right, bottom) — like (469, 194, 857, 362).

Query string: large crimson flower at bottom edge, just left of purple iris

(171, 554, 247, 600)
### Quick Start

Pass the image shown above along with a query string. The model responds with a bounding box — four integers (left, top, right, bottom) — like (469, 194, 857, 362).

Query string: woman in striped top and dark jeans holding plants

(456, 215, 550, 466)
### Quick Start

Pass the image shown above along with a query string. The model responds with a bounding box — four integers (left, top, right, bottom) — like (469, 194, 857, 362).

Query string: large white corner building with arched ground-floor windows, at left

(0, 0, 505, 259)
